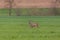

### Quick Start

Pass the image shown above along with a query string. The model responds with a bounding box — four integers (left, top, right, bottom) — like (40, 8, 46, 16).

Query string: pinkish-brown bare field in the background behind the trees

(0, 0, 60, 8)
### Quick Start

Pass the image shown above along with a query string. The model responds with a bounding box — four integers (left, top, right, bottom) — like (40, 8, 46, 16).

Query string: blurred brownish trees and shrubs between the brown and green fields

(6, 0, 60, 16)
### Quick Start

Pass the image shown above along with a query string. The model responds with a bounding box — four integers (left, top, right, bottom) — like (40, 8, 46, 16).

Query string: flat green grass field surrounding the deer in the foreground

(0, 16, 60, 40)
